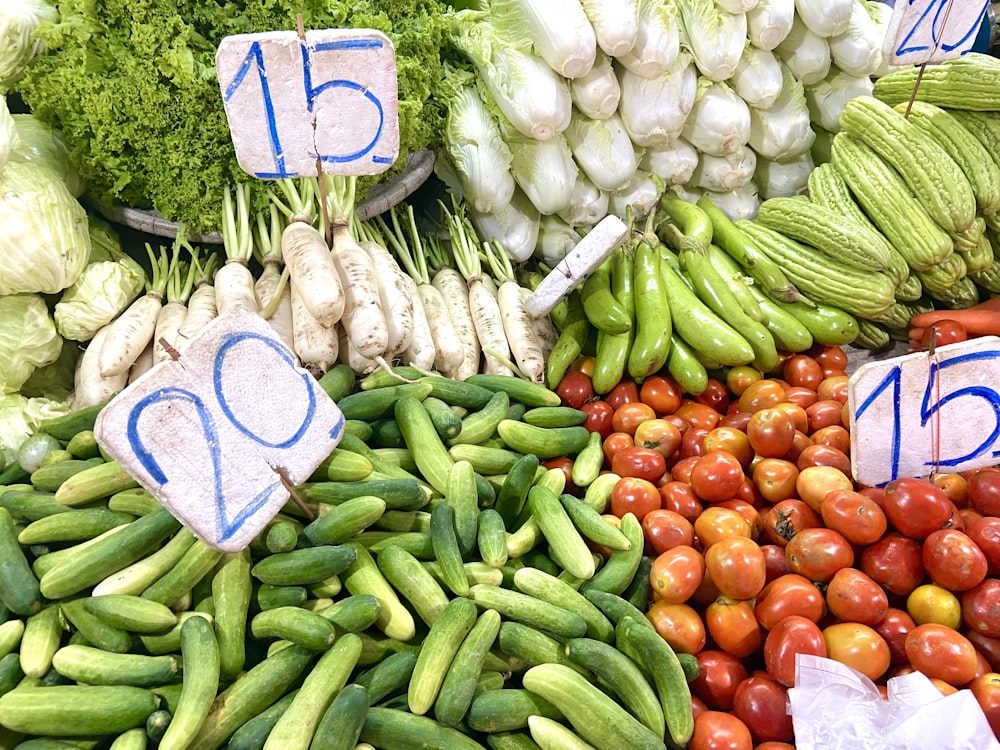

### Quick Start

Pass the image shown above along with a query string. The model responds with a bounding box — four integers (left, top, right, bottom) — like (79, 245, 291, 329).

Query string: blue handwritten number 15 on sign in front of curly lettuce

(222, 39, 392, 179)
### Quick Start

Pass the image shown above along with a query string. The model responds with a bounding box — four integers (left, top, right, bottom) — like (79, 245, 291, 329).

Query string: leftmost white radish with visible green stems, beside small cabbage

(97, 243, 169, 378)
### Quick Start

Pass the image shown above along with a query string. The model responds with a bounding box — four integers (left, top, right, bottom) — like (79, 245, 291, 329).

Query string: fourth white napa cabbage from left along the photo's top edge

(678, 0, 747, 81)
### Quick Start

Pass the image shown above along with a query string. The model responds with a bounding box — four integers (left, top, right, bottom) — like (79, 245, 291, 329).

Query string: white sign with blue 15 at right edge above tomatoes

(848, 336, 1000, 485)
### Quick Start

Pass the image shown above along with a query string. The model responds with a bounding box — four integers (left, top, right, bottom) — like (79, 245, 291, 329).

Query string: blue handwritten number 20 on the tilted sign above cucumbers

(126, 333, 344, 541)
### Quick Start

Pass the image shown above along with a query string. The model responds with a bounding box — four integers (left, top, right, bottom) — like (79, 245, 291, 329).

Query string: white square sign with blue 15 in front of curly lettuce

(215, 29, 399, 178)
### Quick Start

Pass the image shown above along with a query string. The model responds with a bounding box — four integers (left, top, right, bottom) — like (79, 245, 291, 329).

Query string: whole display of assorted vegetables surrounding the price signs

(7, 0, 1000, 750)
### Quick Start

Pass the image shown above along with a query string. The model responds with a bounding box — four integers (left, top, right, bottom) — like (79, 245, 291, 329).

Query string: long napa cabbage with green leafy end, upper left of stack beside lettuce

(452, 10, 573, 141)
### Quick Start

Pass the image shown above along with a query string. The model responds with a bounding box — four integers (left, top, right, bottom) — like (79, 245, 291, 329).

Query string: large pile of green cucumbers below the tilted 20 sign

(0, 365, 697, 750)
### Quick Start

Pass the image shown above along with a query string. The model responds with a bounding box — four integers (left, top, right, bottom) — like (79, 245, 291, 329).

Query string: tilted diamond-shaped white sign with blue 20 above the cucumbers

(94, 312, 344, 552)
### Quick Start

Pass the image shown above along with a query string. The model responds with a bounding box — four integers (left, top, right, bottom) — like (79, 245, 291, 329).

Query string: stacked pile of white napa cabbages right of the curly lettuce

(439, 0, 888, 264)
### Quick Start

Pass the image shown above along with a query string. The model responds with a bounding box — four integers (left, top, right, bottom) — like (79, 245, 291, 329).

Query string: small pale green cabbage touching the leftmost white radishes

(55, 255, 146, 341)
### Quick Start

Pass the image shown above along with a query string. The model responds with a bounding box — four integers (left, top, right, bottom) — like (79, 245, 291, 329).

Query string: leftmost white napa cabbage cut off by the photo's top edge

(490, 0, 597, 78)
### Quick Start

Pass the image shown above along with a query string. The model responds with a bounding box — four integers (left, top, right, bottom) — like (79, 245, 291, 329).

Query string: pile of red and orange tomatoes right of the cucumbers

(557, 347, 1000, 750)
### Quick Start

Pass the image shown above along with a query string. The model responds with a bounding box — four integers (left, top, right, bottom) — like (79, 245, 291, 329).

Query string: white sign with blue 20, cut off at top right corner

(882, 0, 990, 65)
